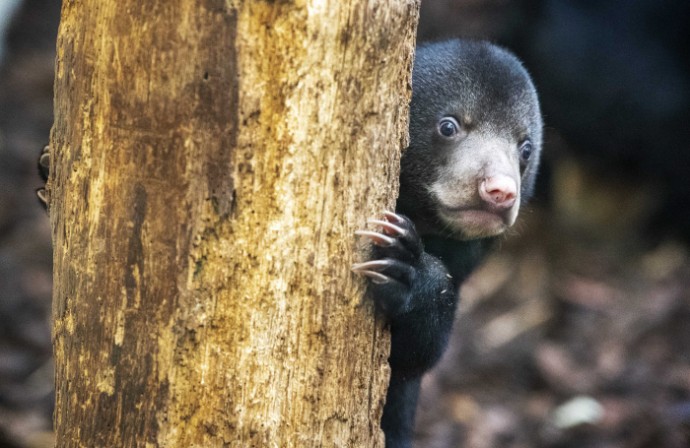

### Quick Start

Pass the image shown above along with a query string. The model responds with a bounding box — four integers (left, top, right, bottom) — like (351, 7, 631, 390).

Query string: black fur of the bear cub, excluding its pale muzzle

(353, 40, 542, 448)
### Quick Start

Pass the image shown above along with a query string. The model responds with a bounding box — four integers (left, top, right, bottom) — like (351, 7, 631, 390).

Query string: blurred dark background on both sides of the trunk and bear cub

(0, 0, 690, 448)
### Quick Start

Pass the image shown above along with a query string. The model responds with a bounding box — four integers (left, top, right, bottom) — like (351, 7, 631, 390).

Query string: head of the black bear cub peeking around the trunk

(399, 42, 542, 239)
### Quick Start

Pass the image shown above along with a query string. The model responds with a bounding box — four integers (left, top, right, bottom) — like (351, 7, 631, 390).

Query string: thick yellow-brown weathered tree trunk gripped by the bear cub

(49, 0, 417, 447)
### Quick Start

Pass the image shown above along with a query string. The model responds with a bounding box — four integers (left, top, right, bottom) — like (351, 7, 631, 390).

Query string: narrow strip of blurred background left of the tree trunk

(0, 0, 60, 448)
